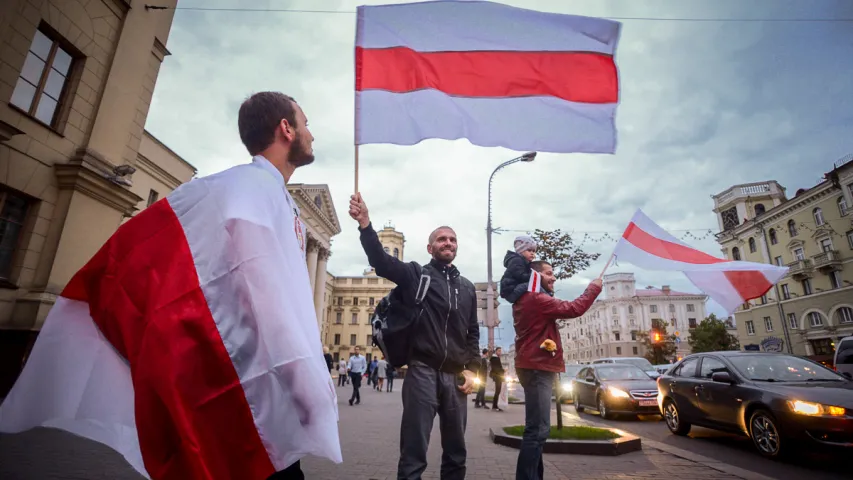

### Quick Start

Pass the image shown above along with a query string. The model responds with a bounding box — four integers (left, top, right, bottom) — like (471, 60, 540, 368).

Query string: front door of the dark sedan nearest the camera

(693, 355, 743, 428)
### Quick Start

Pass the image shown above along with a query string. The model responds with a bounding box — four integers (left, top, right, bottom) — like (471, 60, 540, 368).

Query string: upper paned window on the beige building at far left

(9, 29, 74, 128)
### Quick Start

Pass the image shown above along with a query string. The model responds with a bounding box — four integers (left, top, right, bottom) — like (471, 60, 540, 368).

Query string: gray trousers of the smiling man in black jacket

(397, 361, 468, 480)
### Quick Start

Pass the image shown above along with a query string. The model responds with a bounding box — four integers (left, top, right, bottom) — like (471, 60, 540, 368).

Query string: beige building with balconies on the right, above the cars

(712, 155, 853, 362)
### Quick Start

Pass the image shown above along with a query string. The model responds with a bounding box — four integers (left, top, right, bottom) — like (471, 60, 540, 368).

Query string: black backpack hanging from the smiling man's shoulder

(370, 265, 431, 368)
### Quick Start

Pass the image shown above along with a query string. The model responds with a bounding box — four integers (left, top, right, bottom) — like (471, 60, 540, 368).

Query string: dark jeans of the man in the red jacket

(515, 368, 555, 480)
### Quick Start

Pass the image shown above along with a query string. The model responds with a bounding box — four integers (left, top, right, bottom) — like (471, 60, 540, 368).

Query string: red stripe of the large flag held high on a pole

(355, 47, 619, 103)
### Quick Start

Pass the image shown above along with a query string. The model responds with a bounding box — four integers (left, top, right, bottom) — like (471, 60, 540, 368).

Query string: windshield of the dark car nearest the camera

(729, 355, 845, 382)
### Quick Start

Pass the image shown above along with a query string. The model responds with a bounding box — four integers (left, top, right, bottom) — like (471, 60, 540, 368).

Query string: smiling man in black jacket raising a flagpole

(349, 194, 480, 480)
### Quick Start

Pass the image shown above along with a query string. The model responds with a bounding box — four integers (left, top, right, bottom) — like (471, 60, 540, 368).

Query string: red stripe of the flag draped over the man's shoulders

(62, 199, 274, 480)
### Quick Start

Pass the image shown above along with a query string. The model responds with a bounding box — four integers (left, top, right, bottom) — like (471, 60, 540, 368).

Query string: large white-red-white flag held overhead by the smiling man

(355, 1, 621, 153)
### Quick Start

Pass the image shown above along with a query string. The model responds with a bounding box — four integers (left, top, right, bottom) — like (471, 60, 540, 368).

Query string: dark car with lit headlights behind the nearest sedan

(572, 363, 660, 418)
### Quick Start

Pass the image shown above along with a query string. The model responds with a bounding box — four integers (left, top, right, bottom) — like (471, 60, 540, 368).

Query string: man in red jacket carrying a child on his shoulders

(512, 261, 601, 480)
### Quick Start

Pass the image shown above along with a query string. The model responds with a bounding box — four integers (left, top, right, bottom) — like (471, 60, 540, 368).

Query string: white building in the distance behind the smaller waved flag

(560, 273, 708, 363)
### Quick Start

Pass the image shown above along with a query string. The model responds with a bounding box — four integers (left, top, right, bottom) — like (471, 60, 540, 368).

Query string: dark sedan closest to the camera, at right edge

(658, 351, 853, 458)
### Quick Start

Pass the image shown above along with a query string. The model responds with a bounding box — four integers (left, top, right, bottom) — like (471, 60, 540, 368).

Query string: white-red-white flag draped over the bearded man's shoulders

(0, 157, 342, 480)
